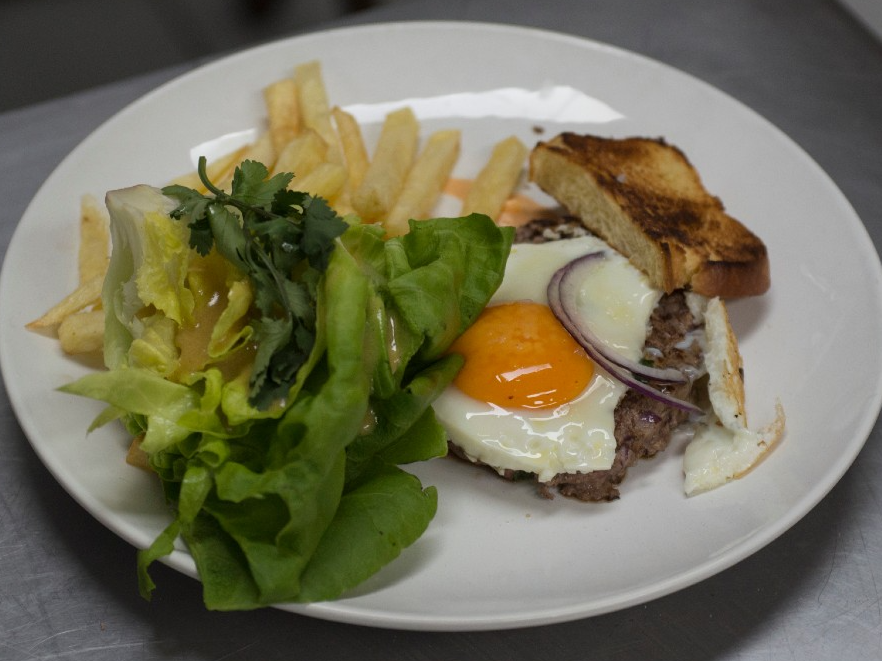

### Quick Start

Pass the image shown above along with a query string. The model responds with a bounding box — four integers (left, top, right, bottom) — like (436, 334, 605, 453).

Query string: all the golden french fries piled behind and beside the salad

(27, 60, 528, 354)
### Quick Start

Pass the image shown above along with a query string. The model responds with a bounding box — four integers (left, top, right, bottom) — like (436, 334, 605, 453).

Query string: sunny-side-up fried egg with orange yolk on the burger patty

(434, 236, 661, 482)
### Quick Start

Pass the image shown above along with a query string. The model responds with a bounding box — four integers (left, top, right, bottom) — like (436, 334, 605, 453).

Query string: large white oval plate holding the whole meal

(0, 23, 882, 630)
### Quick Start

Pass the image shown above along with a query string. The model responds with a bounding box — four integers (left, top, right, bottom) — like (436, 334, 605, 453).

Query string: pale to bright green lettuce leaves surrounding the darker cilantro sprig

(63, 186, 512, 610)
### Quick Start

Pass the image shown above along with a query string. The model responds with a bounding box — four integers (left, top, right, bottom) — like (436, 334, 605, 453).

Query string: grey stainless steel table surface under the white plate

(0, 0, 882, 661)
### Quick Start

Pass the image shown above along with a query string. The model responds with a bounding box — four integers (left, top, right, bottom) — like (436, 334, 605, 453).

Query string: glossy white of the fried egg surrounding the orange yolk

(434, 236, 661, 482)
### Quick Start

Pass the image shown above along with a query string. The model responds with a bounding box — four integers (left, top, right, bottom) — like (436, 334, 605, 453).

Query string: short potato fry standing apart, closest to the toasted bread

(462, 136, 528, 220)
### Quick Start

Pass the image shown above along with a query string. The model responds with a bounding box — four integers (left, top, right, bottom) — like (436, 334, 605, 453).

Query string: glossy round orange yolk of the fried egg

(450, 302, 594, 409)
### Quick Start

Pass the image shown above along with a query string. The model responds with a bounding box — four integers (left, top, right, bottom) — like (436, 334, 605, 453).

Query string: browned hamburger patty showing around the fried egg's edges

(449, 219, 702, 501)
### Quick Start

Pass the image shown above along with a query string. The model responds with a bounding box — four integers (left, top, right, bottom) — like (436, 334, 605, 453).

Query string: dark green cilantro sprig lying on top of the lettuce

(162, 156, 348, 409)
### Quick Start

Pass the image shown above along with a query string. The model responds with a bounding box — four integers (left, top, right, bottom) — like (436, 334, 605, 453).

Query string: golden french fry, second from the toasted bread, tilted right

(384, 130, 460, 236)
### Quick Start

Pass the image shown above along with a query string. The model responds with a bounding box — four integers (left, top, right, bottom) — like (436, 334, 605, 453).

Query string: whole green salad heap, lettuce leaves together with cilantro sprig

(63, 163, 512, 610)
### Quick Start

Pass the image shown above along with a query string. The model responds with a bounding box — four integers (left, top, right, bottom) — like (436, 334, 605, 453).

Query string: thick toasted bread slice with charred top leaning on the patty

(530, 133, 770, 298)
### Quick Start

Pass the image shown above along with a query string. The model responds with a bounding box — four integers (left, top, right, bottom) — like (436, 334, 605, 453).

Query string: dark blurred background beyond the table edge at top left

(0, 0, 395, 112)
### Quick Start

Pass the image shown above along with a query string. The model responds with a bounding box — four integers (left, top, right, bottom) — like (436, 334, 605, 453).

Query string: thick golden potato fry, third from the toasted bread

(352, 108, 419, 221)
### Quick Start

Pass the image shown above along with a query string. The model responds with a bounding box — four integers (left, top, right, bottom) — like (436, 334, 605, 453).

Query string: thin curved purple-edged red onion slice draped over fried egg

(547, 251, 702, 413)
